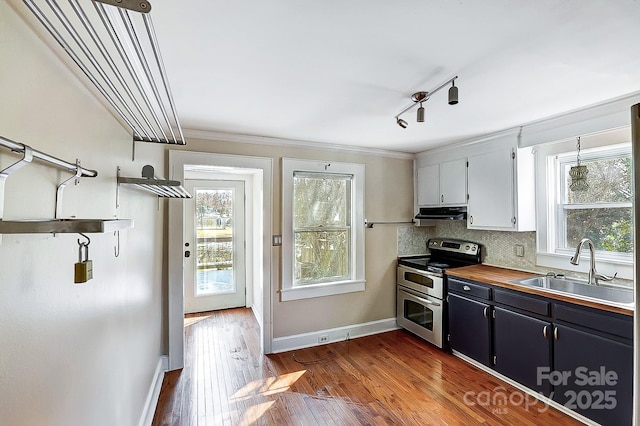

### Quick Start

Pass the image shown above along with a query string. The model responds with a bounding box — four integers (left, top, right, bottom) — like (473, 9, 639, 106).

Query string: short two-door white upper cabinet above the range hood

(417, 158, 467, 207)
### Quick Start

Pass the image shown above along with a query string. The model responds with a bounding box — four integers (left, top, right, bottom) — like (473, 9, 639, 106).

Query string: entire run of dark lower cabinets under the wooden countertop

(447, 278, 633, 426)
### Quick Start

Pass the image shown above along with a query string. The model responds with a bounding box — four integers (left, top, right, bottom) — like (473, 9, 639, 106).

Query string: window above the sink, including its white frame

(537, 131, 633, 279)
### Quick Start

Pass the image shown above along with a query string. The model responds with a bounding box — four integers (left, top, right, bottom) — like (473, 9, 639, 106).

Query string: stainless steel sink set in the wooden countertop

(511, 276, 634, 304)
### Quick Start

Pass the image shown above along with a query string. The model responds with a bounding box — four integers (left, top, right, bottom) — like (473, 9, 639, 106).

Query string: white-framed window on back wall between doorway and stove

(281, 158, 364, 301)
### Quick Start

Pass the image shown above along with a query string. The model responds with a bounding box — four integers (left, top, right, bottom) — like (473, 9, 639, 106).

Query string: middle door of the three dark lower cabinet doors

(493, 307, 553, 397)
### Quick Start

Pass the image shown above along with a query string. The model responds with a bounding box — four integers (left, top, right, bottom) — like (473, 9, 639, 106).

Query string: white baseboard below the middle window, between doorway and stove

(271, 317, 400, 353)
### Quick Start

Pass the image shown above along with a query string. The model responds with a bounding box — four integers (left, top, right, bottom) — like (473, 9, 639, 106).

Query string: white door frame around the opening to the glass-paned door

(167, 150, 273, 370)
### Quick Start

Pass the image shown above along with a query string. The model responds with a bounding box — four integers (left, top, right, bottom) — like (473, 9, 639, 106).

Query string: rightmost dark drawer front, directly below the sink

(554, 303, 633, 339)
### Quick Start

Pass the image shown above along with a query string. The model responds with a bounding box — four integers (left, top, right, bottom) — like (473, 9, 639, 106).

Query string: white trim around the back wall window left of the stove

(280, 158, 365, 302)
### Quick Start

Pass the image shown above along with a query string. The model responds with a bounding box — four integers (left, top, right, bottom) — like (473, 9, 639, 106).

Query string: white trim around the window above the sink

(535, 127, 634, 279)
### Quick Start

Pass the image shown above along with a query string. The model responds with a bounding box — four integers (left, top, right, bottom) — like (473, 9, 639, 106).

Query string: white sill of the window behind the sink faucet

(536, 252, 633, 280)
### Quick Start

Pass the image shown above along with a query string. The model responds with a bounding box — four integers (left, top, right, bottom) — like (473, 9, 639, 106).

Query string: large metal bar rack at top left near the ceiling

(23, 0, 185, 145)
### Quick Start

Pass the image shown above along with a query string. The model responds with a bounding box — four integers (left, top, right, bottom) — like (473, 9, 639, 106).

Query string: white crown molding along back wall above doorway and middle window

(183, 129, 415, 160)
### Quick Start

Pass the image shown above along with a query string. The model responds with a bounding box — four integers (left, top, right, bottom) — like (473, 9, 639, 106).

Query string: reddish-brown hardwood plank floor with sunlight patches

(153, 309, 580, 426)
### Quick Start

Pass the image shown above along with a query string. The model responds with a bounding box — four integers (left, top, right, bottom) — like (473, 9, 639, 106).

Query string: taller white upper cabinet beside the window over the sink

(467, 146, 535, 231)
